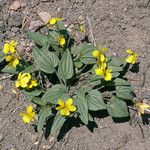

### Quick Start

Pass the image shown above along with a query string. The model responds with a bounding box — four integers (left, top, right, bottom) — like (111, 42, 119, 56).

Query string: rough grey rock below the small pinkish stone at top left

(8, 12, 23, 27)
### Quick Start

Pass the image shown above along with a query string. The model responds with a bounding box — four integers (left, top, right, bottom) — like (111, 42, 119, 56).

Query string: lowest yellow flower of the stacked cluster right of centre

(95, 64, 112, 81)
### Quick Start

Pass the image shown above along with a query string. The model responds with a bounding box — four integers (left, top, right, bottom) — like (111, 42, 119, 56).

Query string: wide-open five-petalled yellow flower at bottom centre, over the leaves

(56, 98, 76, 116)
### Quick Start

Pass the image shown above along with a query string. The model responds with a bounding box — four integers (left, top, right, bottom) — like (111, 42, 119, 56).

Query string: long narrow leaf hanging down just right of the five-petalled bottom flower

(76, 90, 89, 125)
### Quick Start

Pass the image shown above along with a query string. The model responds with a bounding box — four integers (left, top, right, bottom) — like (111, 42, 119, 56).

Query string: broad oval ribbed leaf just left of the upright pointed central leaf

(33, 47, 59, 73)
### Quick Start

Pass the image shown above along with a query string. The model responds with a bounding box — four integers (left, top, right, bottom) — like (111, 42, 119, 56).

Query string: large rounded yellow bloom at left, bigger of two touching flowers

(15, 73, 31, 88)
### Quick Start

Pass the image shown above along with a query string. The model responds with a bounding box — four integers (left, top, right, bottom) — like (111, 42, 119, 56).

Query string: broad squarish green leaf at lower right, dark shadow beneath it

(107, 97, 129, 118)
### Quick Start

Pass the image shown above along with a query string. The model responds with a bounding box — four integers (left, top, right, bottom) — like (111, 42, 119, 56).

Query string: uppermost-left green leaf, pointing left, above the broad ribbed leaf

(28, 32, 48, 46)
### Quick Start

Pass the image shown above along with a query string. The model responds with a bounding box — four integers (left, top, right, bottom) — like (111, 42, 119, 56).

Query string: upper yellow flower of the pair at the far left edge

(3, 40, 17, 54)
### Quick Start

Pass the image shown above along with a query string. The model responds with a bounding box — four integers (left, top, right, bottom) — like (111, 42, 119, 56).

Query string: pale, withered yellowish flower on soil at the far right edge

(134, 102, 150, 115)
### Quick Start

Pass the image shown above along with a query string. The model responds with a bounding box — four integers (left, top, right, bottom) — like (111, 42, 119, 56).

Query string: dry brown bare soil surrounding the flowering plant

(0, 0, 150, 150)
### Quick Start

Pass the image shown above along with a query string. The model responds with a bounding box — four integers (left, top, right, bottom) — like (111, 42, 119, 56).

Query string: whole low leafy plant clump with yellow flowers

(0, 18, 149, 138)
